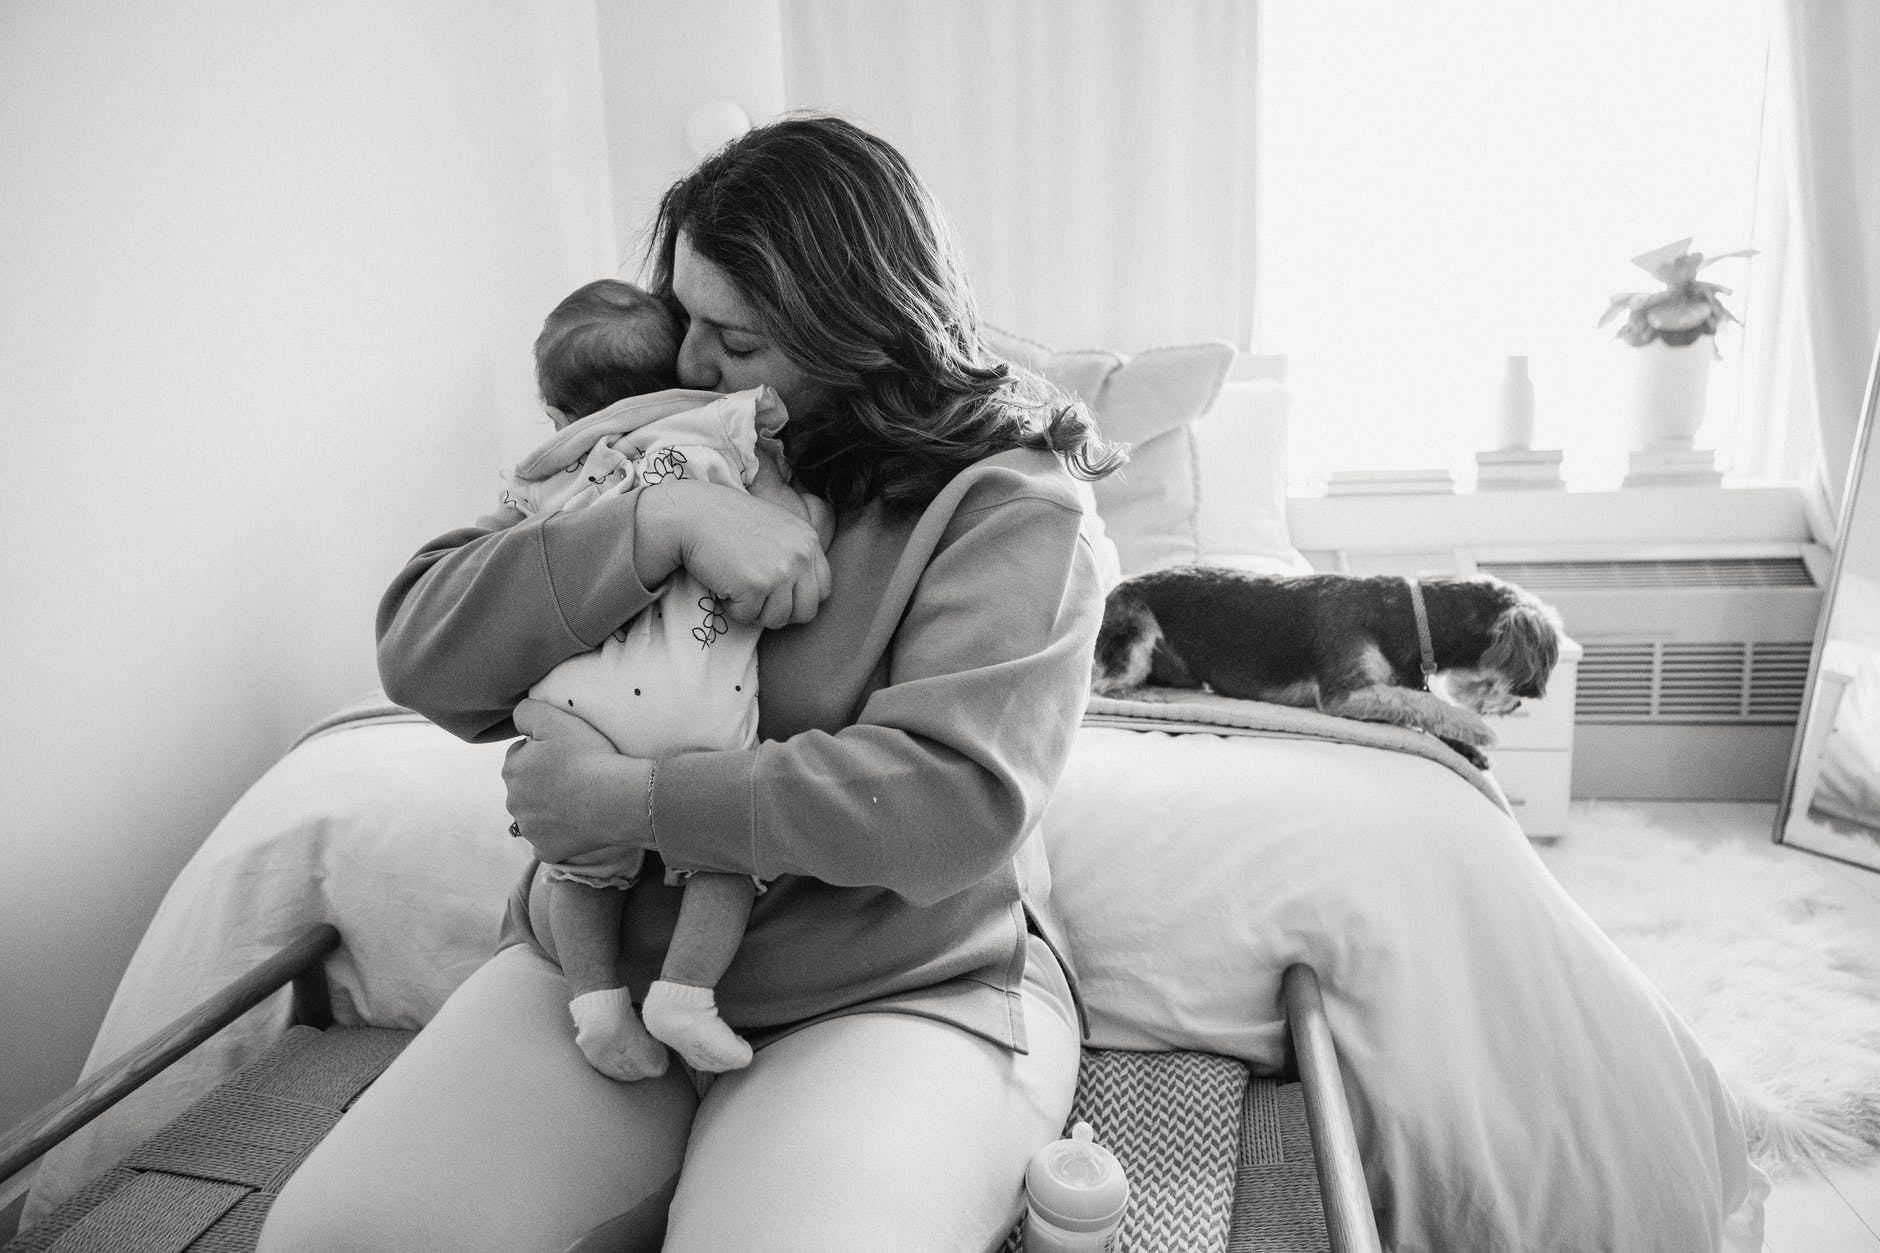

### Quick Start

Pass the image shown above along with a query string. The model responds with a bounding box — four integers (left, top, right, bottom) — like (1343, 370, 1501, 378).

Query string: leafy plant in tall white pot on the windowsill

(1600, 239, 1756, 462)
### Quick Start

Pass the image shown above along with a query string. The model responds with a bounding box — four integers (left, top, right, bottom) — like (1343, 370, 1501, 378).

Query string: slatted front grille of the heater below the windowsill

(1574, 642, 1812, 722)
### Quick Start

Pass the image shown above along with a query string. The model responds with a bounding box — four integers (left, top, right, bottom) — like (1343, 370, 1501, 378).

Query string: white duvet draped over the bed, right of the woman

(1047, 728, 1767, 1253)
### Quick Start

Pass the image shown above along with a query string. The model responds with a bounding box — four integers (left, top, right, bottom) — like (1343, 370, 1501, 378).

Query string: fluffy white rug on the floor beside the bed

(1542, 805, 1880, 1170)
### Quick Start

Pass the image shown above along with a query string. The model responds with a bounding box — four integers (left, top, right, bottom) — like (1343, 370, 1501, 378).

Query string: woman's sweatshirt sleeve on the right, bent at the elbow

(652, 481, 1102, 903)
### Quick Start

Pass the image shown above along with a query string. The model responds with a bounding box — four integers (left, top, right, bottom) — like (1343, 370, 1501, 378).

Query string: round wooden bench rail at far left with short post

(0, 922, 340, 1182)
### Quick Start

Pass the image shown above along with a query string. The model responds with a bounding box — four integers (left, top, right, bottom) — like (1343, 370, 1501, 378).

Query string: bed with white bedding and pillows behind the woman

(11, 339, 1763, 1251)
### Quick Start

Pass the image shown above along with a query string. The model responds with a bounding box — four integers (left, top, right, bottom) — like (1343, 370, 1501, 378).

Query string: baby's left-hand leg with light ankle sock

(549, 879, 666, 1082)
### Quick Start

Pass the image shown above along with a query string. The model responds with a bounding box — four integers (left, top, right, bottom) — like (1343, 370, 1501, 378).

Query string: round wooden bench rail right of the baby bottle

(1280, 963, 1384, 1253)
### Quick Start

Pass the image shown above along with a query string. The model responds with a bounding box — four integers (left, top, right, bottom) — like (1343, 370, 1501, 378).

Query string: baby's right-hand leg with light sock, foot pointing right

(645, 875, 758, 1072)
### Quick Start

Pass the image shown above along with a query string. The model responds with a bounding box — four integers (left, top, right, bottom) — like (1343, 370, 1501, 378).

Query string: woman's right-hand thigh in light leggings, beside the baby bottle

(667, 940, 1081, 1253)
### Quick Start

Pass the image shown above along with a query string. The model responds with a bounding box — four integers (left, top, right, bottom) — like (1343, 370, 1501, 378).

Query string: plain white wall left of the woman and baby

(0, 0, 615, 1127)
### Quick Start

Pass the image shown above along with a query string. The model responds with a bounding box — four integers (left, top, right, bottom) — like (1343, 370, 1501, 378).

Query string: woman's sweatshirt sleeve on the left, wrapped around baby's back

(378, 491, 656, 741)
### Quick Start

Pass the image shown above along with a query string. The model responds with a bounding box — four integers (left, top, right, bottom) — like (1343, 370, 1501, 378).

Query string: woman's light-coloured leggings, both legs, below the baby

(259, 937, 1079, 1253)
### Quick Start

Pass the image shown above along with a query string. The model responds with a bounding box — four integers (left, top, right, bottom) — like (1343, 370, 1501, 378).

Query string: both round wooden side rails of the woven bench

(0, 924, 1382, 1253)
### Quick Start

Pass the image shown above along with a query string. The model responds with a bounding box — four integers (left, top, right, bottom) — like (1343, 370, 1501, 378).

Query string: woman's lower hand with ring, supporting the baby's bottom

(502, 700, 652, 873)
